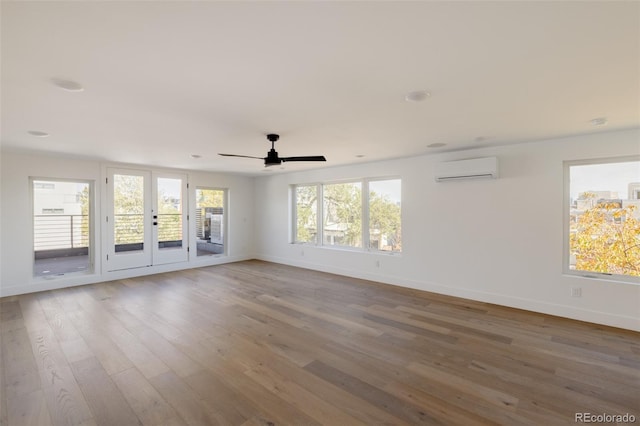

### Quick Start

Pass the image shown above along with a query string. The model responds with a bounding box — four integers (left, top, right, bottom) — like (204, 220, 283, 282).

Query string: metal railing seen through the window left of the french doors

(33, 215, 89, 251)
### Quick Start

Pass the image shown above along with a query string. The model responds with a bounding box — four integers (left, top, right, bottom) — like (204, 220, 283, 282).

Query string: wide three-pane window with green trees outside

(293, 178, 402, 252)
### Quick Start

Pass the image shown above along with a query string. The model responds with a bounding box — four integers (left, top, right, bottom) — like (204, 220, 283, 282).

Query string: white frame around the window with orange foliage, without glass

(562, 155, 640, 284)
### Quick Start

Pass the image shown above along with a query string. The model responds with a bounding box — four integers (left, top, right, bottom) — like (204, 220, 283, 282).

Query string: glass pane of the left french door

(113, 174, 144, 253)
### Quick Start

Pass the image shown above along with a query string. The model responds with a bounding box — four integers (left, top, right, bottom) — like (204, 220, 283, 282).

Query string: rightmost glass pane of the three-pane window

(369, 179, 402, 252)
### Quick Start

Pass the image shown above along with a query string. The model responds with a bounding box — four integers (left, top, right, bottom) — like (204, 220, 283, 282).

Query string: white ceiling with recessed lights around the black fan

(1, 1, 640, 174)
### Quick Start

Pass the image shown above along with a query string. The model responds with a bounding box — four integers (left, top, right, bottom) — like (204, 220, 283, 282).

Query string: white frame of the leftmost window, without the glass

(29, 176, 99, 281)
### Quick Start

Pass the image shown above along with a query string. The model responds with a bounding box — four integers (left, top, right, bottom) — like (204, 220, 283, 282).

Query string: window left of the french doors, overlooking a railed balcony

(31, 179, 93, 277)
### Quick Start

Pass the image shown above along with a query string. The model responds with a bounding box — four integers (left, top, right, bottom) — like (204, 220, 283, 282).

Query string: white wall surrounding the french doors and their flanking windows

(0, 152, 254, 296)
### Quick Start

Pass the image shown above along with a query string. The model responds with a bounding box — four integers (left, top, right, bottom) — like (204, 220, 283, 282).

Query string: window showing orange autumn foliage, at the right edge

(565, 158, 640, 281)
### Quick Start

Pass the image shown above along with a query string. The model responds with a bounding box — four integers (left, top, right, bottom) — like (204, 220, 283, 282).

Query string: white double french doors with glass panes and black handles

(106, 168, 188, 271)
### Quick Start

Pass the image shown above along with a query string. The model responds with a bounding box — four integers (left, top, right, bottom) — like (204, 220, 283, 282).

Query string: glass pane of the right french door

(158, 178, 182, 249)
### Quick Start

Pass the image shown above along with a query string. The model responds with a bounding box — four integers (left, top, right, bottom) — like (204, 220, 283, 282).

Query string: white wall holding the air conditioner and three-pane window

(255, 129, 640, 330)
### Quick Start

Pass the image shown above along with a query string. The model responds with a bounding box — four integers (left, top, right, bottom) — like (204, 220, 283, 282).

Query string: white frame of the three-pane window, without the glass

(289, 175, 402, 256)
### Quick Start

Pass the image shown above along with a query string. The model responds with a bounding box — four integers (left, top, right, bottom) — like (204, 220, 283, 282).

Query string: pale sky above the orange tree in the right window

(570, 161, 640, 200)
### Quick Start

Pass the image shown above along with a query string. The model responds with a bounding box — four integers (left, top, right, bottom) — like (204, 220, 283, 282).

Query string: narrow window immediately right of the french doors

(196, 188, 227, 256)
